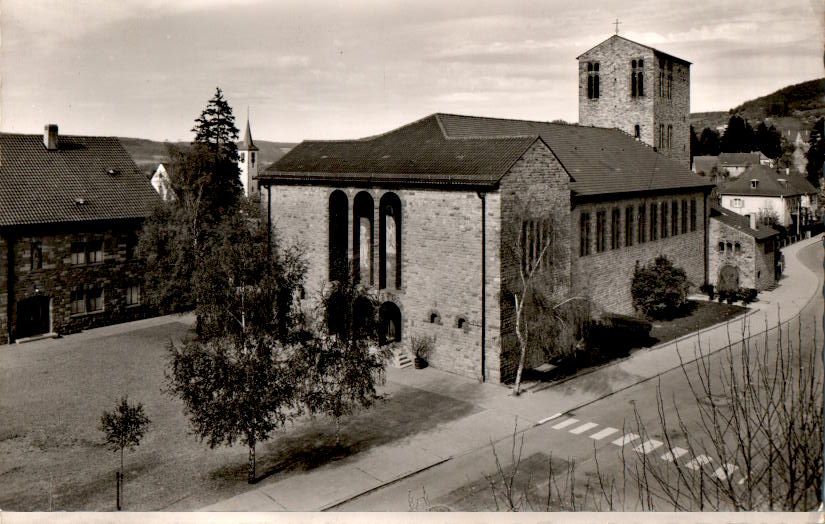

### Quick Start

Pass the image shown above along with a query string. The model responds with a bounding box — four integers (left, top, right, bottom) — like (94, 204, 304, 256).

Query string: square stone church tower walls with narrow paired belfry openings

(578, 35, 691, 168)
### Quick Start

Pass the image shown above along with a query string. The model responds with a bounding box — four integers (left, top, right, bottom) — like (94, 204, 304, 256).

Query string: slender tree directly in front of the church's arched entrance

(301, 271, 391, 446)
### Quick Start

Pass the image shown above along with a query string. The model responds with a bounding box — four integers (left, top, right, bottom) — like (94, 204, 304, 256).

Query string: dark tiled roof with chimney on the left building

(0, 133, 159, 226)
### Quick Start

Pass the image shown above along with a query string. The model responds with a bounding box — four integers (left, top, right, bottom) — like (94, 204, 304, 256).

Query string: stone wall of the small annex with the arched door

(708, 219, 774, 291)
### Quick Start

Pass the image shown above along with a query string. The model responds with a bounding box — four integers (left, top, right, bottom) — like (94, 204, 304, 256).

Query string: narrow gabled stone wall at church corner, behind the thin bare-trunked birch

(500, 142, 570, 380)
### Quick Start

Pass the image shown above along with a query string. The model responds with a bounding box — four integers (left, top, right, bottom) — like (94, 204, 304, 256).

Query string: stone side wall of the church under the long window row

(570, 193, 705, 314)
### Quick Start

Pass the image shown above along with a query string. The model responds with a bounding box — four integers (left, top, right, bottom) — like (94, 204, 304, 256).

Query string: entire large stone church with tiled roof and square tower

(259, 36, 712, 382)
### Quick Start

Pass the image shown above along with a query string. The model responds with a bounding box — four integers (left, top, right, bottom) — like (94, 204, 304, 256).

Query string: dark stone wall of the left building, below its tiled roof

(0, 225, 151, 342)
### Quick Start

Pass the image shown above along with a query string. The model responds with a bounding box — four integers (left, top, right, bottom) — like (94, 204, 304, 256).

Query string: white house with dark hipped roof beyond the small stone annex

(719, 165, 805, 232)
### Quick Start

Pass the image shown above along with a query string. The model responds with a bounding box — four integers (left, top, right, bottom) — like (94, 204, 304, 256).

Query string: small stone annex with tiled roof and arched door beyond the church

(708, 204, 781, 291)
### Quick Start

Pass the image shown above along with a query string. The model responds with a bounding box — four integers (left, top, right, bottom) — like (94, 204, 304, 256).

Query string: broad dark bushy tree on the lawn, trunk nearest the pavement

(167, 334, 299, 484)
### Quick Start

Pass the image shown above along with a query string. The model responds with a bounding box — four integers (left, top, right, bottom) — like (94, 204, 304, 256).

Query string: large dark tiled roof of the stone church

(261, 113, 712, 195)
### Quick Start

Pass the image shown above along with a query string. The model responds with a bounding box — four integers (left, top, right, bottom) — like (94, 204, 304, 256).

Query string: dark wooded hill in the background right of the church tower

(690, 78, 825, 140)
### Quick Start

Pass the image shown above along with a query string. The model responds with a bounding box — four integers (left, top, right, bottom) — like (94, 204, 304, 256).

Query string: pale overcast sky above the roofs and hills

(0, 0, 825, 141)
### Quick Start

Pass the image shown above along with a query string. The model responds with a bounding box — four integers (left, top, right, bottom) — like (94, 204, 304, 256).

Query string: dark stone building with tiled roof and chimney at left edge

(0, 125, 160, 342)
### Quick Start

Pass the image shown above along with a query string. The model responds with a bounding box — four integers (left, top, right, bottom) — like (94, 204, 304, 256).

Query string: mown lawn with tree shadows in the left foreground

(0, 321, 475, 511)
